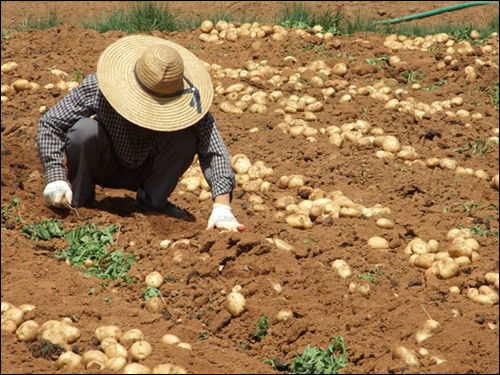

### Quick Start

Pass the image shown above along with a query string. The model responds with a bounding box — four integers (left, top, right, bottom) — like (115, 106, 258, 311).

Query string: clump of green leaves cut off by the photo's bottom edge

(291, 336, 349, 374)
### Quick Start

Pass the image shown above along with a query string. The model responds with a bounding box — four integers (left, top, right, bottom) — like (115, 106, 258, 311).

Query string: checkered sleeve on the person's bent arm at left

(38, 74, 99, 184)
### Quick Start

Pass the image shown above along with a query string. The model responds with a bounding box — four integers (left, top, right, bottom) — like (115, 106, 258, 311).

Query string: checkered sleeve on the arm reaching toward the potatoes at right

(194, 112, 236, 199)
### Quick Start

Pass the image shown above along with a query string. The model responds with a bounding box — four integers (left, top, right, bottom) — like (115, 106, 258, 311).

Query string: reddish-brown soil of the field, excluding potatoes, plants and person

(1, 2, 499, 373)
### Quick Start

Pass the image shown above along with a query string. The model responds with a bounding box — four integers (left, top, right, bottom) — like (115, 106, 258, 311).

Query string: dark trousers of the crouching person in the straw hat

(66, 118, 198, 207)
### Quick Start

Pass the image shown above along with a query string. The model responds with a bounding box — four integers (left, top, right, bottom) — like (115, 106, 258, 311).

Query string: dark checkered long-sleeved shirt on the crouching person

(38, 73, 236, 198)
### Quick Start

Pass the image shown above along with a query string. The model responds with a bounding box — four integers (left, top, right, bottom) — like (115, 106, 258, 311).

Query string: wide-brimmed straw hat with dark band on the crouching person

(97, 35, 214, 131)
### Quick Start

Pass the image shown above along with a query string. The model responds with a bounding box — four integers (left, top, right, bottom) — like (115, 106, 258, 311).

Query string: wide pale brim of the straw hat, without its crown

(97, 35, 214, 131)
